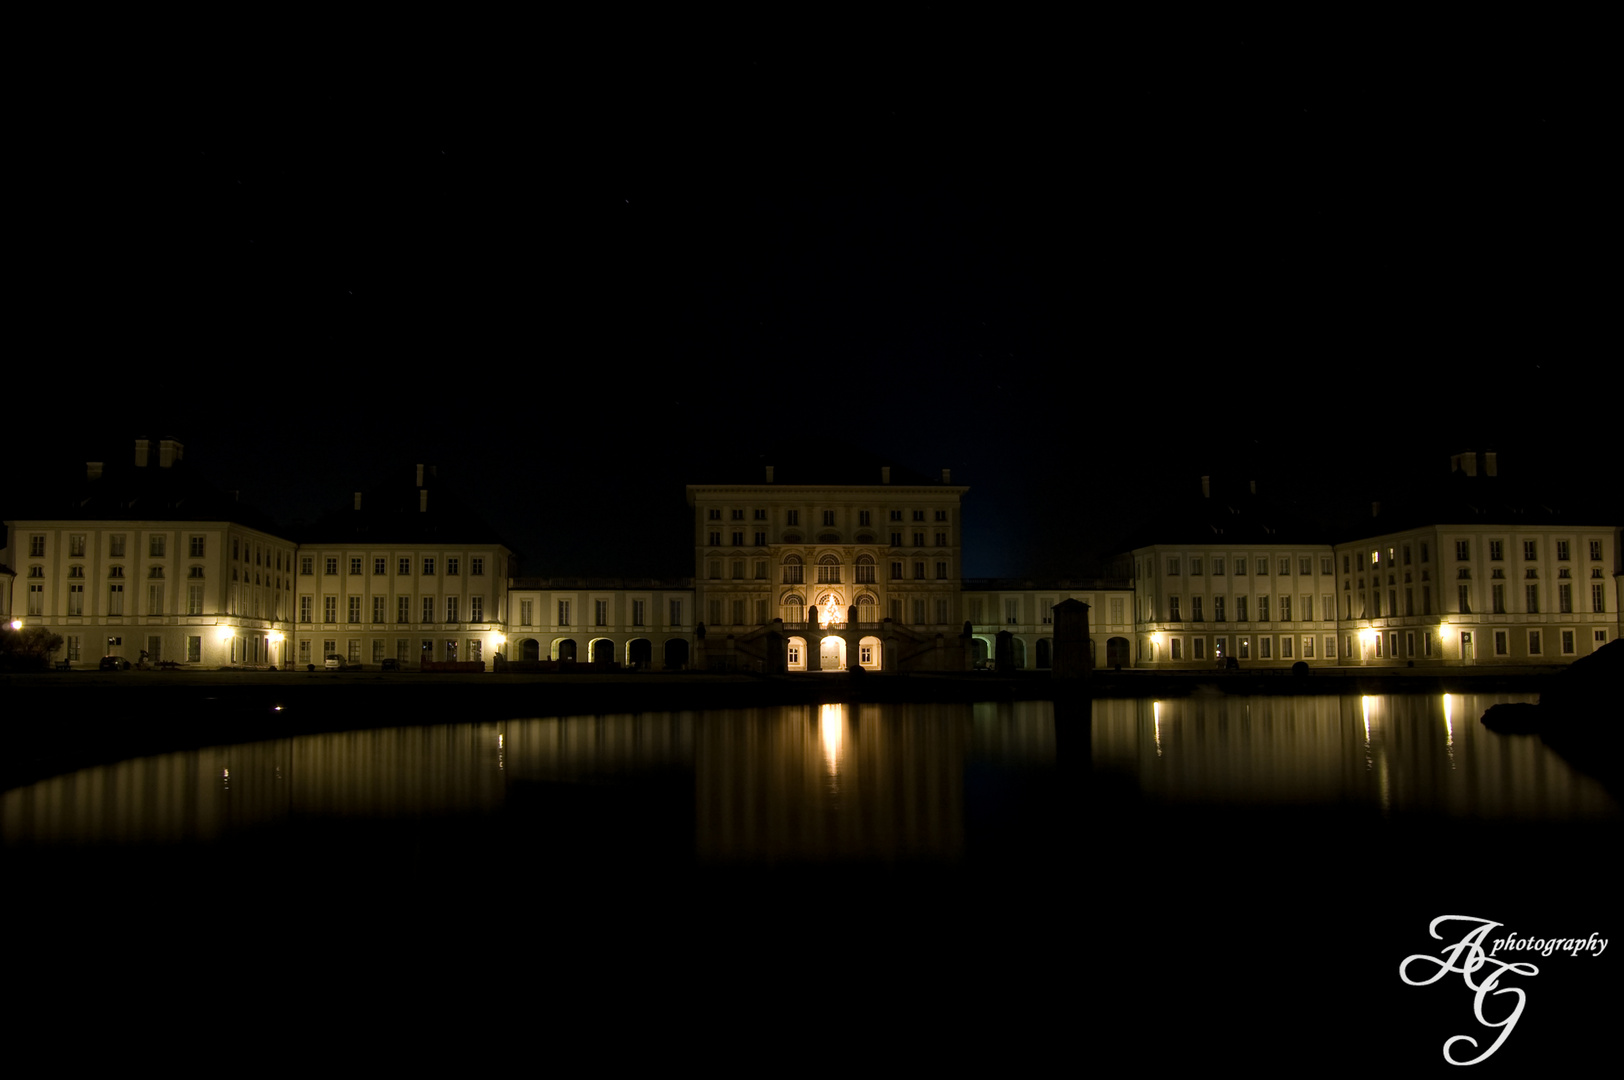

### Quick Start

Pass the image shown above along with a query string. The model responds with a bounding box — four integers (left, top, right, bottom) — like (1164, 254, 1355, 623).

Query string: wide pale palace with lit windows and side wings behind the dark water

(0, 440, 1624, 672)
